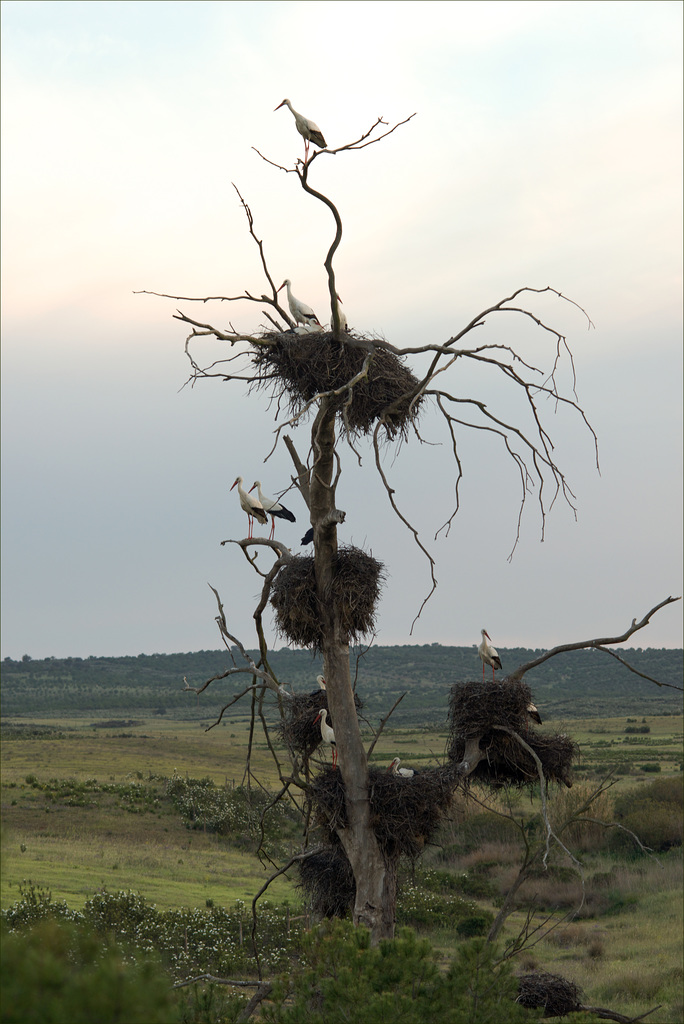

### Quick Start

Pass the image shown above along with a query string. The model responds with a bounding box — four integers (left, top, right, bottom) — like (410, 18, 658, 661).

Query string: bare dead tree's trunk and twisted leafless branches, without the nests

(144, 108, 673, 954)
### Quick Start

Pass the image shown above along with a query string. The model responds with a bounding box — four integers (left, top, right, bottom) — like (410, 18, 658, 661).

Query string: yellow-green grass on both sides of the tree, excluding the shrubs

(1, 716, 682, 1024)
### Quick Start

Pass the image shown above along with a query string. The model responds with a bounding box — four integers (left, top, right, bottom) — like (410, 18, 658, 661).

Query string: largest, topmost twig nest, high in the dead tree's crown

(252, 331, 422, 440)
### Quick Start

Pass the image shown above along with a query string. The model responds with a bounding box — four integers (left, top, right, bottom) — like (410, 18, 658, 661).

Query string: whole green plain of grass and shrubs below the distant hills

(1, 716, 683, 1024)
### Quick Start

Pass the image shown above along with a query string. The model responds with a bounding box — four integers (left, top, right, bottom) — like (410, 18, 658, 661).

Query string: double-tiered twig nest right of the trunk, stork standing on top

(448, 682, 580, 788)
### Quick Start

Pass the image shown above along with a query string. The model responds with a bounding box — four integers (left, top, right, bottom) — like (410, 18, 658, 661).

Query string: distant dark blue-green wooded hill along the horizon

(1, 644, 684, 727)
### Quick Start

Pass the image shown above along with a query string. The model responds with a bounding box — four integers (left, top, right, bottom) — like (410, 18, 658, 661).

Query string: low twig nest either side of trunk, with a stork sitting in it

(311, 765, 457, 860)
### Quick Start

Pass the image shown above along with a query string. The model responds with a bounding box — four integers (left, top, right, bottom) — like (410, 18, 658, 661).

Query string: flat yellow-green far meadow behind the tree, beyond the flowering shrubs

(1, 716, 682, 907)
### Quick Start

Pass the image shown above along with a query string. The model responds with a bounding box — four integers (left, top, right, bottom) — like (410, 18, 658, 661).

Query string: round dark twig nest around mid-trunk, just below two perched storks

(270, 547, 385, 651)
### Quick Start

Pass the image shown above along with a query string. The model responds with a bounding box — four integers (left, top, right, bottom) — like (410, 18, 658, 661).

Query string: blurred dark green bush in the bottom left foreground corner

(0, 920, 179, 1024)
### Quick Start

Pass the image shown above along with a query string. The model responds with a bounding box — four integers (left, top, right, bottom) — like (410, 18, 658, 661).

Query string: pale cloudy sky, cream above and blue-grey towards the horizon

(2, 0, 682, 657)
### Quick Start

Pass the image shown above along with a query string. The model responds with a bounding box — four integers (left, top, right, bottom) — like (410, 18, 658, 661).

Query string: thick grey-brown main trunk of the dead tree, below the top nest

(310, 399, 396, 943)
